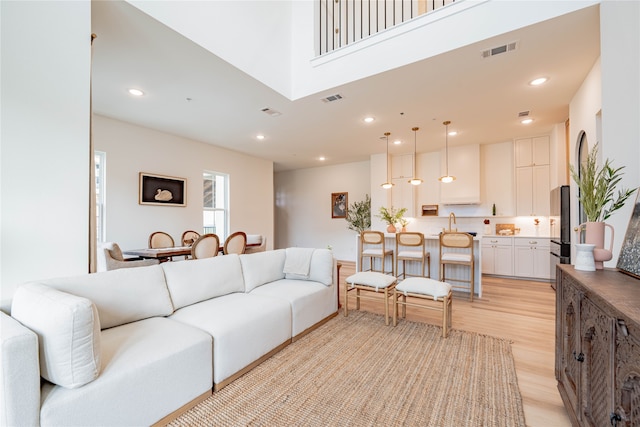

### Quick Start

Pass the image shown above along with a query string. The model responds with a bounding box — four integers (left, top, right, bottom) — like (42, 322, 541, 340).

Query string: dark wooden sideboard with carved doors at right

(555, 264, 640, 427)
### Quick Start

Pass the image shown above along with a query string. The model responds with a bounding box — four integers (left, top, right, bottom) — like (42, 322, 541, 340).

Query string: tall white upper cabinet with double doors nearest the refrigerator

(514, 136, 551, 216)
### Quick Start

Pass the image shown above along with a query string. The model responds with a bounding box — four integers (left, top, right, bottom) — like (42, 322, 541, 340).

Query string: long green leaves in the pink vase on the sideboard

(569, 145, 637, 222)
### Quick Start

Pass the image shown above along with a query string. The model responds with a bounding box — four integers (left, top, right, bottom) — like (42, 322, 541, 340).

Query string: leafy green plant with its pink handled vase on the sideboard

(570, 145, 637, 269)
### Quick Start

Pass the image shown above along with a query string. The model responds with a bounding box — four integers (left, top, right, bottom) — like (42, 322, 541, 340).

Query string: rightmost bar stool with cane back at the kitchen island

(440, 231, 475, 302)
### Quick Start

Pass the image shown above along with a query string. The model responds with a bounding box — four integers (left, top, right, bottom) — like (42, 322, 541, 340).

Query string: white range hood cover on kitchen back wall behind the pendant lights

(440, 144, 480, 205)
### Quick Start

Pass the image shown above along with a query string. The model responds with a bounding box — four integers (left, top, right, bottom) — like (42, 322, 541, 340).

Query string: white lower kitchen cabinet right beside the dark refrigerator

(513, 237, 551, 280)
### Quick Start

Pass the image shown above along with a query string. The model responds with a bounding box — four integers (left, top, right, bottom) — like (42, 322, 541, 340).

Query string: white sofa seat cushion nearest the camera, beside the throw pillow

(40, 317, 213, 427)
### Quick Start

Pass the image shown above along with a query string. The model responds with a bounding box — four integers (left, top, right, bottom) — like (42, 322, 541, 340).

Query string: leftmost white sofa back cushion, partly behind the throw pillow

(31, 265, 173, 329)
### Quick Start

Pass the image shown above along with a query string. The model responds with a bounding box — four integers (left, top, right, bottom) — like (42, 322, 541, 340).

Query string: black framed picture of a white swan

(138, 172, 187, 206)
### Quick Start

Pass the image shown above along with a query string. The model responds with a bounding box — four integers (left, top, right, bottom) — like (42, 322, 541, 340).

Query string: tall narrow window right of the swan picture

(202, 172, 229, 242)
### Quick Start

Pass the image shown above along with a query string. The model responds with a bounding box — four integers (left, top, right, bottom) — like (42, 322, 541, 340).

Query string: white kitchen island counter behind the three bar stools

(356, 233, 482, 298)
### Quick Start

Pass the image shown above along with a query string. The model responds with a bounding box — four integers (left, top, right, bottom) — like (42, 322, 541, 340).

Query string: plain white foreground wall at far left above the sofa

(0, 1, 91, 300)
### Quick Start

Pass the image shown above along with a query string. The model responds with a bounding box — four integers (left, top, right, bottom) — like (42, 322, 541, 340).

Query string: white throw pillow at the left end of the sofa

(11, 283, 100, 388)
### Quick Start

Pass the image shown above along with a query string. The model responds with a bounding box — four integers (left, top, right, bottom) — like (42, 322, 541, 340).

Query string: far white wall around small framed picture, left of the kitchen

(275, 162, 370, 261)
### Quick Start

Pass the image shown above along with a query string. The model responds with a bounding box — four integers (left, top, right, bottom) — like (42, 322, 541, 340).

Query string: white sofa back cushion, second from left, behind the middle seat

(162, 254, 244, 310)
